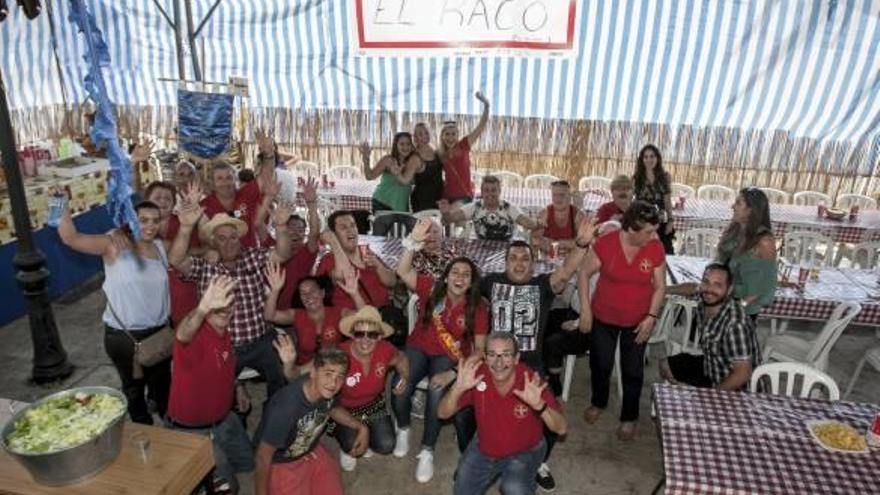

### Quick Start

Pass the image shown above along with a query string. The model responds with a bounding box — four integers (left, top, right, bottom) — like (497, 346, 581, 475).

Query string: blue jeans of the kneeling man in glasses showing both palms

(453, 436, 547, 495)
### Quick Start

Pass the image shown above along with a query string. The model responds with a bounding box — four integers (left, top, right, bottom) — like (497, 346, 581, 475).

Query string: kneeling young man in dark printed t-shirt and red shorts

(254, 347, 370, 495)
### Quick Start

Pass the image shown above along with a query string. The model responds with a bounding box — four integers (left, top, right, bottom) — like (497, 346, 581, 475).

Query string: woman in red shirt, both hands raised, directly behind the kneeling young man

(263, 261, 364, 370)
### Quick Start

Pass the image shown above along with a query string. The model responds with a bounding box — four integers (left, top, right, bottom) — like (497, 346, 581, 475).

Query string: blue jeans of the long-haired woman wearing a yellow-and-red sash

(391, 346, 476, 451)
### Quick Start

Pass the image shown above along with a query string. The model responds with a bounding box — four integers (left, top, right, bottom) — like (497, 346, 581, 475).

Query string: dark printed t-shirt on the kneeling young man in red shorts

(260, 375, 335, 463)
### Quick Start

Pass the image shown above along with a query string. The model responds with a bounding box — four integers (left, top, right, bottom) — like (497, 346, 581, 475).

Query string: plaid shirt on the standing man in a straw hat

(184, 248, 272, 347)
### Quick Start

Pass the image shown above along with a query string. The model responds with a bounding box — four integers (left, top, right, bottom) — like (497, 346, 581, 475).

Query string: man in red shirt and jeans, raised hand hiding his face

(166, 276, 254, 493)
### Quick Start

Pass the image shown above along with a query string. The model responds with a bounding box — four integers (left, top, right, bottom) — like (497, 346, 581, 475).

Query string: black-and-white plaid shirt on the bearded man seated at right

(695, 297, 761, 386)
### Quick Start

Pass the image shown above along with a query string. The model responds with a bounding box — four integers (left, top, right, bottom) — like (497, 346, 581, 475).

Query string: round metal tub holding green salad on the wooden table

(0, 387, 128, 486)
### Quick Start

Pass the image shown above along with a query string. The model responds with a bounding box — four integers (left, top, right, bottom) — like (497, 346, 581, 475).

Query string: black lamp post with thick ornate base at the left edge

(0, 70, 73, 383)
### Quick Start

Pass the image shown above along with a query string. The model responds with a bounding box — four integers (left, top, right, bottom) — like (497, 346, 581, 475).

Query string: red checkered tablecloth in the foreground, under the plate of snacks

(654, 384, 880, 495)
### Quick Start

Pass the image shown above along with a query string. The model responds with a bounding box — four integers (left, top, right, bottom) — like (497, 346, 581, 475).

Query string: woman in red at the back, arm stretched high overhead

(437, 91, 489, 203)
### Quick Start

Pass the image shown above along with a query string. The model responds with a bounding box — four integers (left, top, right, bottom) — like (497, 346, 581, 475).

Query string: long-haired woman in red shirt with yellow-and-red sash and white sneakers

(392, 219, 489, 483)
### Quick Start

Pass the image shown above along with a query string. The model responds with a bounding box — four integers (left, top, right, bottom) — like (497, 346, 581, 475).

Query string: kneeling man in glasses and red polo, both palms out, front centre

(437, 332, 568, 494)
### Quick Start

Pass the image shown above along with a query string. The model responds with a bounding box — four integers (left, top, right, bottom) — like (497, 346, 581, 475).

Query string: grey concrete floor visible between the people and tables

(0, 283, 880, 495)
